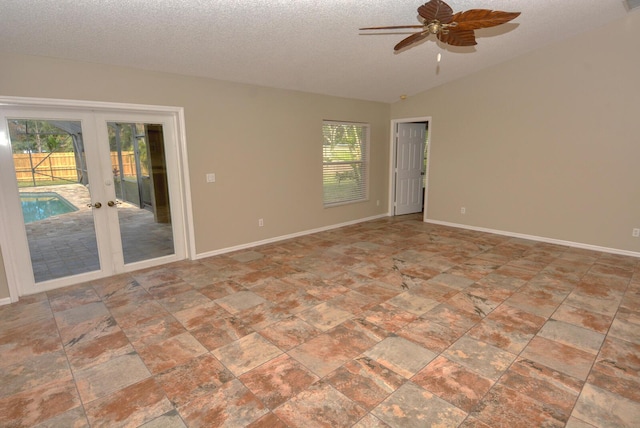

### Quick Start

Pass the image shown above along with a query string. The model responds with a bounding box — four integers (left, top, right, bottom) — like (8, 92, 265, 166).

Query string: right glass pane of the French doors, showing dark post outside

(107, 122, 174, 264)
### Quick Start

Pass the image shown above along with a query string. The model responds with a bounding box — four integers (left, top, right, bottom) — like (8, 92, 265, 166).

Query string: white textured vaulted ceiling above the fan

(0, 0, 635, 102)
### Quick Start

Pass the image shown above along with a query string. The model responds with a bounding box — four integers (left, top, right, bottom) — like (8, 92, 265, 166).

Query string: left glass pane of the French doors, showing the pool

(8, 119, 100, 282)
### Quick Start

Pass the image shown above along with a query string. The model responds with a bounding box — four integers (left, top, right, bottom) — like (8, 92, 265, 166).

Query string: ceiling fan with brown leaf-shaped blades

(360, 0, 520, 51)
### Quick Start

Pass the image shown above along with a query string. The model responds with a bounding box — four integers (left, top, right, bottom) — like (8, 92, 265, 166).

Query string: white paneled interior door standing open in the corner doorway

(395, 123, 427, 215)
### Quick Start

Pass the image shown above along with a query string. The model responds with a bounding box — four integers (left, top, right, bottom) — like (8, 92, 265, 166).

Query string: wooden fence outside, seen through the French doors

(13, 151, 136, 183)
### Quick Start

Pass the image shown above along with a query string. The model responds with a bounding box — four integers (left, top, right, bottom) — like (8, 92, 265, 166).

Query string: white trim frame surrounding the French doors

(0, 96, 195, 302)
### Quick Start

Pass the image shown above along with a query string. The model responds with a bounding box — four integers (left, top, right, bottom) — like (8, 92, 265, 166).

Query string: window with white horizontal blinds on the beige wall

(322, 121, 369, 207)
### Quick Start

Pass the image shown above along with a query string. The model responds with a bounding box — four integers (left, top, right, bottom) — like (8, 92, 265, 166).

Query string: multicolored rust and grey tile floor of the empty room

(0, 215, 640, 428)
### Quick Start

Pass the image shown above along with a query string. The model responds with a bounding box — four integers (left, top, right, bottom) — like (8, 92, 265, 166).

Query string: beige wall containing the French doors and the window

(0, 54, 390, 296)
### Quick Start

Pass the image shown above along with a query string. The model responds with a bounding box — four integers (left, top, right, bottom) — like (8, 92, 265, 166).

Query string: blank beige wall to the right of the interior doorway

(391, 13, 640, 252)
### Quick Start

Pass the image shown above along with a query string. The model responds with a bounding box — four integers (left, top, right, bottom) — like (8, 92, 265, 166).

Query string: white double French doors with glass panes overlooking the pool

(0, 107, 186, 295)
